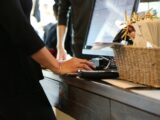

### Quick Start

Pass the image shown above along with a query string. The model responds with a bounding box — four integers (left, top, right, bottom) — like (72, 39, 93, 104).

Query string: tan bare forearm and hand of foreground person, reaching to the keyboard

(32, 47, 94, 75)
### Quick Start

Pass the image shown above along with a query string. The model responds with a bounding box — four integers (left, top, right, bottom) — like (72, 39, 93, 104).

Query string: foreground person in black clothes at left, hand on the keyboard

(0, 0, 93, 120)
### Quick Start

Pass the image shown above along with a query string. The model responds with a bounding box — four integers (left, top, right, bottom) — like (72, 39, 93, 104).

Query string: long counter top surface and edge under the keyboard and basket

(43, 70, 160, 116)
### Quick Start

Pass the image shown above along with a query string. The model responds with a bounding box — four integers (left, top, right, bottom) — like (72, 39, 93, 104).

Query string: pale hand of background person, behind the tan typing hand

(56, 48, 67, 60)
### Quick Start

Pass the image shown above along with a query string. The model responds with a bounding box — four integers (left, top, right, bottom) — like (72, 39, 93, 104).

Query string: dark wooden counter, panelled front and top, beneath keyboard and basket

(42, 70, 160, 120)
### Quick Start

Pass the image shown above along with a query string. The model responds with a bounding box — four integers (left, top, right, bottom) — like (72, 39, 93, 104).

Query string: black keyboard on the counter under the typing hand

(78, 70, 119, 79)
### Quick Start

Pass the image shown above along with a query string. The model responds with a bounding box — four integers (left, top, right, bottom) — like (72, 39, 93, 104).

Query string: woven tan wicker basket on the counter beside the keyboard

(113, 45, 160, 87)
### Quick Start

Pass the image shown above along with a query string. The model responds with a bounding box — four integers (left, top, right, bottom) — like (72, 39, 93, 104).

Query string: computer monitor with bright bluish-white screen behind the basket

(82, 0, 139, 57)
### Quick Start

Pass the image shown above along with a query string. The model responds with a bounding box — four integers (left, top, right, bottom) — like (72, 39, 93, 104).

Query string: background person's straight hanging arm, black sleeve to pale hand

(57, 0, 71, 60)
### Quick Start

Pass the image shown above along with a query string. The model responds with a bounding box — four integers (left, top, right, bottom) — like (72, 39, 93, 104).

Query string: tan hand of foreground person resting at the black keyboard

(60, 57, 95, 75)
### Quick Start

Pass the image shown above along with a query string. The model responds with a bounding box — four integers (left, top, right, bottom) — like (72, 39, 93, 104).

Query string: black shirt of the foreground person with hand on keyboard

(0, 0, 44, 97)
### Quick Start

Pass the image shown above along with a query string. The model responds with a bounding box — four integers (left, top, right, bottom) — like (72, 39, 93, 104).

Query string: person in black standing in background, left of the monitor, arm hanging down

(57, 0, 94, 59)
